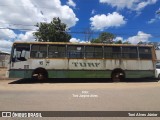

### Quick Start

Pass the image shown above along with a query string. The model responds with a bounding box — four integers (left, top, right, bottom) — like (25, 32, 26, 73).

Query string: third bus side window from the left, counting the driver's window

(48, 45, 66, 58)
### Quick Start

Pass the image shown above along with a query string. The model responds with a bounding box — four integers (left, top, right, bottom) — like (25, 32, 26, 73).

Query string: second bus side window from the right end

(122, 46, 138, 59)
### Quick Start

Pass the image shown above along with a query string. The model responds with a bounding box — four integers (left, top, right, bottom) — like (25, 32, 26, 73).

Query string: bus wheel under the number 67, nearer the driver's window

(32, 67, 48, 81)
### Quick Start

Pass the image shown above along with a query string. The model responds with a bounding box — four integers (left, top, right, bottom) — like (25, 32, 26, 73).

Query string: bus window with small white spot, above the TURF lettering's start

(67, 45, 84, 58)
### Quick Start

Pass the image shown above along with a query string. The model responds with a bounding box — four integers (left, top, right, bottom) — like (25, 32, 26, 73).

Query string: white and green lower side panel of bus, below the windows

(9, 59, 155, 78)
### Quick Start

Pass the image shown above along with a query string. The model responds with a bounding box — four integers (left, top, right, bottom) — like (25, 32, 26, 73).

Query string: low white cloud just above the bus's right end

(125, 31, 152, 44)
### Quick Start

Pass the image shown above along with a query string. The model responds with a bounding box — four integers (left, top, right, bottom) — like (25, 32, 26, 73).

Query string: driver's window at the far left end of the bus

(12, 44, 30, 62)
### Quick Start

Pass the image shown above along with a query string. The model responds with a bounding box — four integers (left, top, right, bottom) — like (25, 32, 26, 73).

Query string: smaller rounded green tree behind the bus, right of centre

(91, 32, 115, 43)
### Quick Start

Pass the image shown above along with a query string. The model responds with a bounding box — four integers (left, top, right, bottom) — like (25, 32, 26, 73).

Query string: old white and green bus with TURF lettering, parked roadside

(7, 42, 156, 82)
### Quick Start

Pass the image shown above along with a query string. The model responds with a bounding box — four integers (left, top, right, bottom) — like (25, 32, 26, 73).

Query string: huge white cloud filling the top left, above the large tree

(0, 0, 79, 29)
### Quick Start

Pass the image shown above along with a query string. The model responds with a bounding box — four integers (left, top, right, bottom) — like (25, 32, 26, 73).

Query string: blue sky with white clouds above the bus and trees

(0, 0, 160, 52)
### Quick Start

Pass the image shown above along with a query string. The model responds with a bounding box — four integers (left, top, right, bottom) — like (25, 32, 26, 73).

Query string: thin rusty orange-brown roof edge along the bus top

(13, 42, 153, 47)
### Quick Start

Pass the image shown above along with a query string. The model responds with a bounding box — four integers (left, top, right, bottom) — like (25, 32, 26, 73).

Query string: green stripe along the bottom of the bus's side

(9, 69, 154, 78)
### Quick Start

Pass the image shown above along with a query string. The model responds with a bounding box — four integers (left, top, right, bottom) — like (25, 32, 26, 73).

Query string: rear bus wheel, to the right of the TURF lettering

(111, 68, 125, 82)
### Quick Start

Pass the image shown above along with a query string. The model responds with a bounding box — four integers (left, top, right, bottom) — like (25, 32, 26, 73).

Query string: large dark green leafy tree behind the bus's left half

(33, 18, 71, 42)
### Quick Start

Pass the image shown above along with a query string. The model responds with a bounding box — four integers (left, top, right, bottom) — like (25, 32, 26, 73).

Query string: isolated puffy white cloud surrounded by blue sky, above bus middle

(90, 12, 126, 30)
